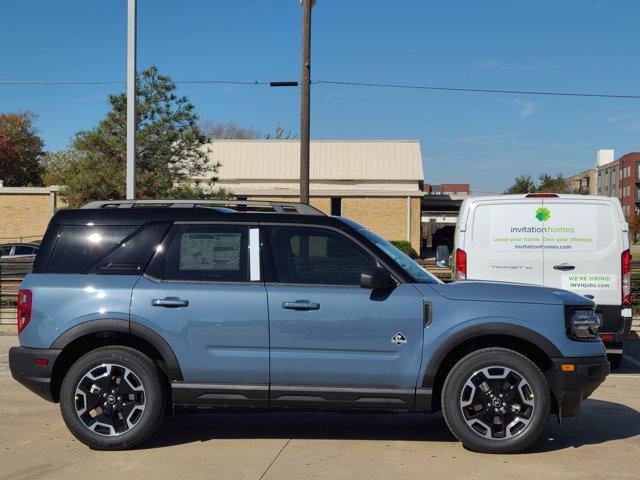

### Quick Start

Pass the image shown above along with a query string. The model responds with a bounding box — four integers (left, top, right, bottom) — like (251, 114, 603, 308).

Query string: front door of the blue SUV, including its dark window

(267, 226, 424, 408)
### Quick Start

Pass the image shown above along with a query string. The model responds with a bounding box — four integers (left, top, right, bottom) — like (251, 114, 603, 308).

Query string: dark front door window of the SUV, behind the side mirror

(271, 227, 376, 285)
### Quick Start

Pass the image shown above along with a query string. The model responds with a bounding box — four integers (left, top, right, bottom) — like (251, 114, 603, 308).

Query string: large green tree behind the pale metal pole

(46, 66, 220, 207)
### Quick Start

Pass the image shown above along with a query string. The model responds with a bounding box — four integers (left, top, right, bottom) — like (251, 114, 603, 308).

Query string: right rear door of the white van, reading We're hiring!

(541, 198, 626, 305)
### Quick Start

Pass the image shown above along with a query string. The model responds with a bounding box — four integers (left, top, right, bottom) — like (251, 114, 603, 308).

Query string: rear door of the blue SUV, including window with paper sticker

(131, 223, 269, 405)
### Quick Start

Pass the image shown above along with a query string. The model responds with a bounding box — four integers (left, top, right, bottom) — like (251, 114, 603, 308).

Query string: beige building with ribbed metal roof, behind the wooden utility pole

(194, 140, 424, 252)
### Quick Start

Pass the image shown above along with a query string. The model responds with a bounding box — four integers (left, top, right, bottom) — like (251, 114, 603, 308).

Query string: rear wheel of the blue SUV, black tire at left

(60, 346, 166, 450)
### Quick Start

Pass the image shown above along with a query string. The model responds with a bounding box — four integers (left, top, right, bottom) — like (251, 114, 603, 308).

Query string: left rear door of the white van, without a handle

(458, 198, 545, 285)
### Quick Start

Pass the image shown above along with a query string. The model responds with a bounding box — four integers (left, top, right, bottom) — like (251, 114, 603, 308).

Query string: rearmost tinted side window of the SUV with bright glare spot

(47, 225, 138, 273)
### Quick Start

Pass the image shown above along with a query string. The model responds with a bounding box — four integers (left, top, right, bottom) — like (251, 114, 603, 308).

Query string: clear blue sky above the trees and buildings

(0, 0, 640, 192)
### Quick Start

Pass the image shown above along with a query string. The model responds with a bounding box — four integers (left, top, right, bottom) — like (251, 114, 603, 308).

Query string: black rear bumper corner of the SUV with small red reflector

(9, 347, 60, 402)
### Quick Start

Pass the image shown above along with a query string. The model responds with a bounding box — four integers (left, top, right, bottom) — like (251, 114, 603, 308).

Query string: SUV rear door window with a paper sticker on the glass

(164, 225, 249, 282)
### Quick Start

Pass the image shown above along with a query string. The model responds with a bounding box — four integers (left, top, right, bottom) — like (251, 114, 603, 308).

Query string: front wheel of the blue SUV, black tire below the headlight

(441, 347, 551, 453)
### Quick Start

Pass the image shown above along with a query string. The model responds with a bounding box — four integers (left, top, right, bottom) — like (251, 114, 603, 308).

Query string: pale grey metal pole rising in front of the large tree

(127, 0, 137, 200)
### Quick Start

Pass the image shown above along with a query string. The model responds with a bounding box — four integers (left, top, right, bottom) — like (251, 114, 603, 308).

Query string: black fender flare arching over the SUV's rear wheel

(50, 318, 183, 382)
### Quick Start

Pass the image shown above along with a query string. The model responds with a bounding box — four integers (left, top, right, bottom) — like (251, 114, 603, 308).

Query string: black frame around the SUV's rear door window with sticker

(143, 220, 265, 285)
